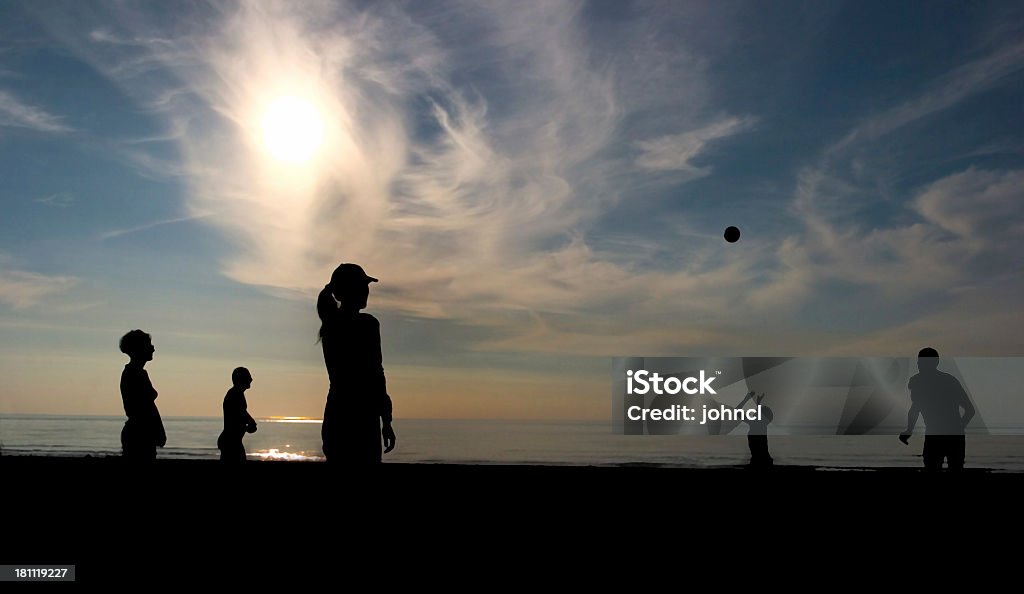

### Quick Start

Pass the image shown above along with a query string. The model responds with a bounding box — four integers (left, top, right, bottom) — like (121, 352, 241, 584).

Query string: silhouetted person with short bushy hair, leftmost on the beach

(119, 330, 167, 463)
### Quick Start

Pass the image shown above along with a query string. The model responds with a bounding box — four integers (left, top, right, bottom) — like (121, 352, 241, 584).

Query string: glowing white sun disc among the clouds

(263, 96, 324, 164)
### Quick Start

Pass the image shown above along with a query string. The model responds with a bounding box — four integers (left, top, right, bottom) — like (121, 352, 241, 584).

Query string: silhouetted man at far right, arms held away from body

(899, 347, 975, 471)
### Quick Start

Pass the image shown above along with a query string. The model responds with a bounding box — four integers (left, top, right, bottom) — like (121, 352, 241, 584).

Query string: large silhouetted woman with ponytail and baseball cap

(316, 263, 395, 465)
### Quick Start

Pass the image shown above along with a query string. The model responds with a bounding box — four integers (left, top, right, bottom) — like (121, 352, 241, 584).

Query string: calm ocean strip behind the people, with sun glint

(0, 415, 1024, 472)
